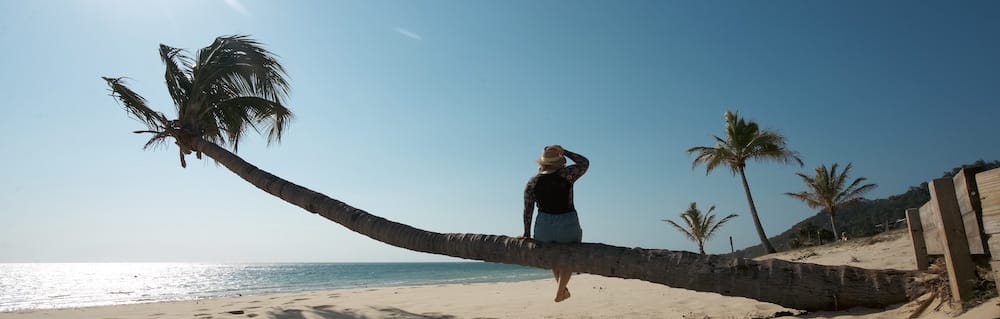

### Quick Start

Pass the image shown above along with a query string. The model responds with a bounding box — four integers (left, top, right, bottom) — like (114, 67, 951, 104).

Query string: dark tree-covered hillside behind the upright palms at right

(734, 160, 1000, 257)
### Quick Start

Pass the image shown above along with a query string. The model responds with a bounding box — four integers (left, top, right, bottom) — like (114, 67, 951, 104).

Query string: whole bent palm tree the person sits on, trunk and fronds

(104, 36, 914, 310)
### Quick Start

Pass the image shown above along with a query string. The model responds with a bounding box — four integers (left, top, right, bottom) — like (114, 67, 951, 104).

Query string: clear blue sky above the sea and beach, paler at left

(0, 0, 1000, 262)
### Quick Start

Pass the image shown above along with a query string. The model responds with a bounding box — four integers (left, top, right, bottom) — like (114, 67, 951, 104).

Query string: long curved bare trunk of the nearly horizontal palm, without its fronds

(190, 138, 915, 311)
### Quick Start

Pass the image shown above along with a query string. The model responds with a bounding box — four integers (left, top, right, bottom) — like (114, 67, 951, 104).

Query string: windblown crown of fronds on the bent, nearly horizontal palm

(104, 35, 292, 166)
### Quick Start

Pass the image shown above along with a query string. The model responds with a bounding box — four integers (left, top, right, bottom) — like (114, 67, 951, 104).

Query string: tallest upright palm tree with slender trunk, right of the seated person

(687, 111, 802, 254)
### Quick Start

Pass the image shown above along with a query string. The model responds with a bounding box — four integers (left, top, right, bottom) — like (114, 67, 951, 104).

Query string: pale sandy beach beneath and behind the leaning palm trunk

(0, 232, 1000, 319)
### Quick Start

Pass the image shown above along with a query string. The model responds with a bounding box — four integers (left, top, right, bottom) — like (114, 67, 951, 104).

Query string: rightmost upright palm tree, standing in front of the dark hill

(785, 163, 876, 236)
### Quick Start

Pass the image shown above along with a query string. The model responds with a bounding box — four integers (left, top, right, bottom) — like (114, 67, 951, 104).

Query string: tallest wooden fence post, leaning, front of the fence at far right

(929, 178, 976, 305)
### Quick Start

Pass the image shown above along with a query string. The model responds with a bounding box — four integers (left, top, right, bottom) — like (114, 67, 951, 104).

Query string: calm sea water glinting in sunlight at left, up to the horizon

(0, 262, 551, 312)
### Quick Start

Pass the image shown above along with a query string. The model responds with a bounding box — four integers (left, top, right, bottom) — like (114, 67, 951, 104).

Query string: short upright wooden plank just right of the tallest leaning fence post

(952, 167, 986, 255)
